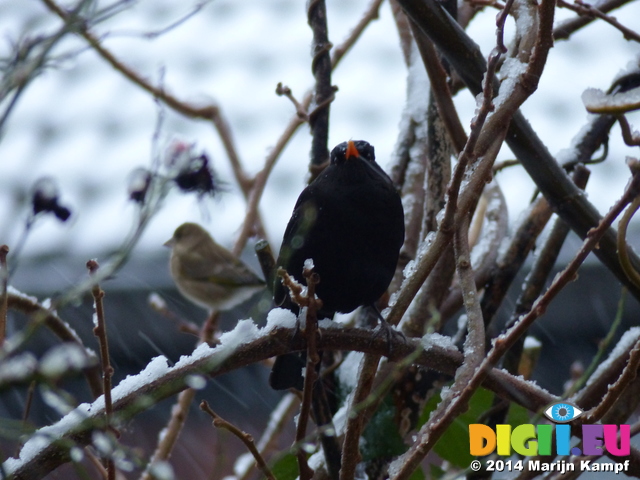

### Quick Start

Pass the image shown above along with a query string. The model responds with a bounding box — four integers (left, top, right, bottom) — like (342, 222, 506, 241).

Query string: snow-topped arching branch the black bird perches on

(12, 318, 640, 478)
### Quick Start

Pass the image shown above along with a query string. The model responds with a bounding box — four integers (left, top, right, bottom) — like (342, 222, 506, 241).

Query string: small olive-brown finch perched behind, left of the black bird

(165, 223, 265, 311)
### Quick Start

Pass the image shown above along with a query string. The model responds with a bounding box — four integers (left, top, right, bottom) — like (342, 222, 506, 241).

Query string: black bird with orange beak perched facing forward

(270, 140, 404, 389)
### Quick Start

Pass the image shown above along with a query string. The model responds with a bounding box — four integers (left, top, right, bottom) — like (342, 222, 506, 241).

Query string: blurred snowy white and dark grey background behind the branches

(0, 0, 640, 478)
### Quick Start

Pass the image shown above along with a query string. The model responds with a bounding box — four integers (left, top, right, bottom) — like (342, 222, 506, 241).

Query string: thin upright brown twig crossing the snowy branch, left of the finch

(87, 260, 117, 480)
